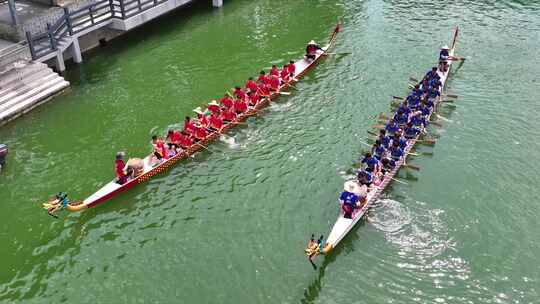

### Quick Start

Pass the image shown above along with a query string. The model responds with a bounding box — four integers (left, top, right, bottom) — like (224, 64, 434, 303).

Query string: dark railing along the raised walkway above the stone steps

(24, 0, 167, 60)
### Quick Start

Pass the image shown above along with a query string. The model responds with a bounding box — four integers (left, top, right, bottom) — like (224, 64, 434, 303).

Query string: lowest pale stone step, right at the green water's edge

(0, 77, 69, 124)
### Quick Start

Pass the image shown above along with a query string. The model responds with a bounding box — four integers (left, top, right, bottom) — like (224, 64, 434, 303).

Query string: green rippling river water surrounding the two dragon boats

(0, 0, 540, 303)
